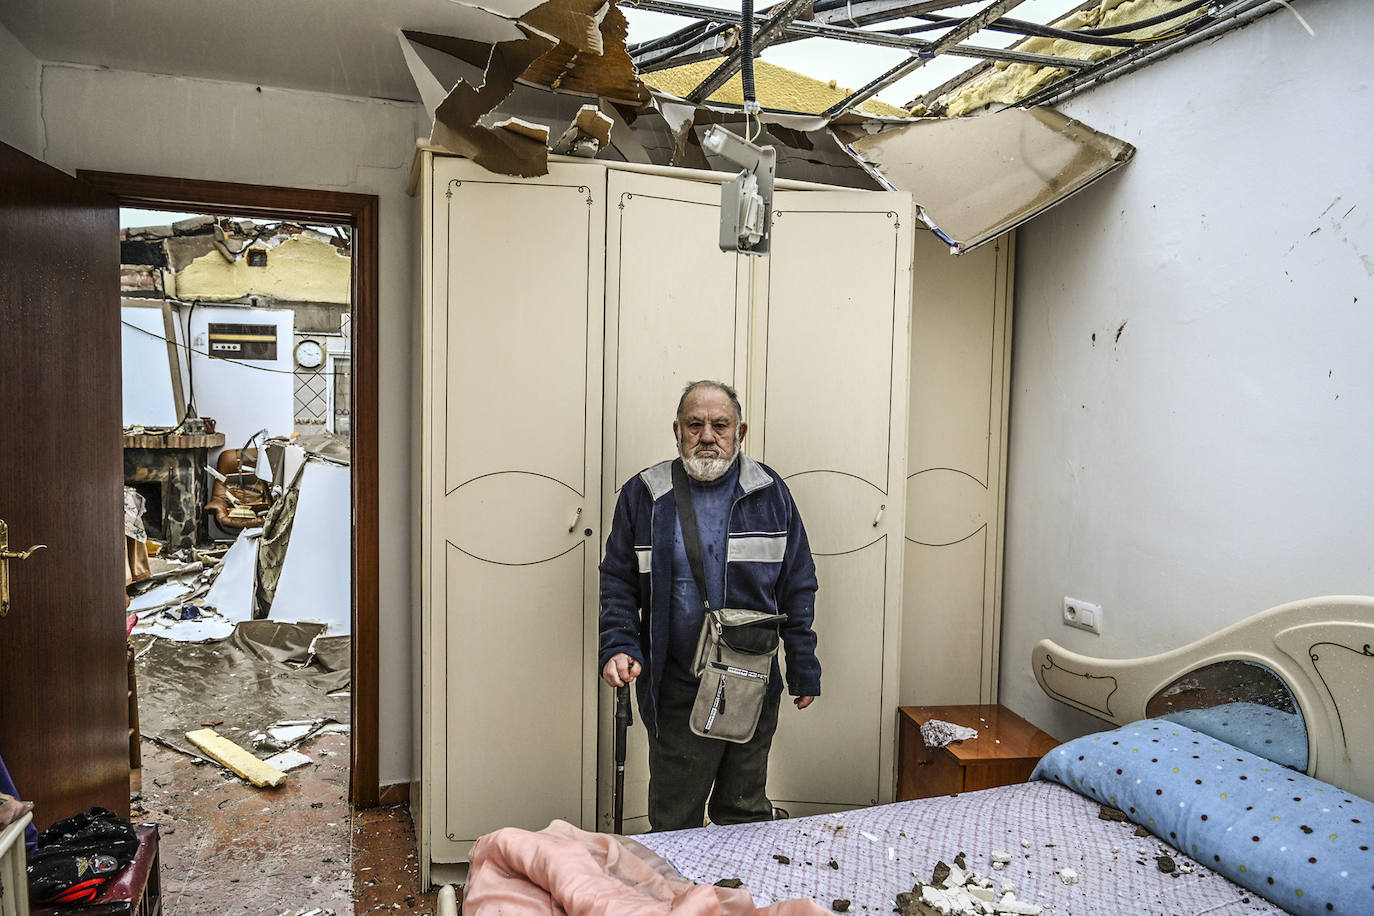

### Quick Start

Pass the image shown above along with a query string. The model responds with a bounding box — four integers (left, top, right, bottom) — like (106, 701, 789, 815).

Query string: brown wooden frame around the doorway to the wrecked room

(77, 170, 381, 808)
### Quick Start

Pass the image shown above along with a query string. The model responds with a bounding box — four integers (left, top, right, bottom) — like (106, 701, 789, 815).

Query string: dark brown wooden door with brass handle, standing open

(0, 144, 129, 827)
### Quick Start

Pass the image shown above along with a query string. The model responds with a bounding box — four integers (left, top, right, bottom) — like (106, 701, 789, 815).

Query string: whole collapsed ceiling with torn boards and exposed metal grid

(0, 0, 1287, 251)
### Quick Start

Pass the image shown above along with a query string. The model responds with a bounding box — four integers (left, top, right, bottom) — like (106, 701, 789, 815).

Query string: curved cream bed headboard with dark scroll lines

(1031, 596, 1374, 799)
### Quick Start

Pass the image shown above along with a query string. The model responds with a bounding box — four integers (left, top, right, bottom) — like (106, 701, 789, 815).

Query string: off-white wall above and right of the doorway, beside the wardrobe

(33, 60, 429, 784)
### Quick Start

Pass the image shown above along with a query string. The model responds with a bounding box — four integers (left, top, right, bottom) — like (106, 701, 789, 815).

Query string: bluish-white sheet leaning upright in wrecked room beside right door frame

(269, 459, 353, 636)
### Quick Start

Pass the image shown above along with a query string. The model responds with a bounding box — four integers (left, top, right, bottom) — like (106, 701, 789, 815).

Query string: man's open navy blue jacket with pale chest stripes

(598, 455, 820, 735)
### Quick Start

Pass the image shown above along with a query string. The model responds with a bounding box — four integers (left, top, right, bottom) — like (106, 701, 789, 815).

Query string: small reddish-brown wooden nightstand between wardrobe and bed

(897, 706, 1059, 802)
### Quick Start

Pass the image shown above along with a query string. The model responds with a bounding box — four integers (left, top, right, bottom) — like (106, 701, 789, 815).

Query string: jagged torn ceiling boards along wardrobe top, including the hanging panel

(400, 0, 1135, 254)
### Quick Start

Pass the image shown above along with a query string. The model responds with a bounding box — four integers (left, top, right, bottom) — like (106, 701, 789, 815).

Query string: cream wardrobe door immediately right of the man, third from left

(749, 191, 912, 814)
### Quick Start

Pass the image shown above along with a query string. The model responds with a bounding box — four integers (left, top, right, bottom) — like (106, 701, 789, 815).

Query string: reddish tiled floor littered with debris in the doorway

(133, 735, 436, 916)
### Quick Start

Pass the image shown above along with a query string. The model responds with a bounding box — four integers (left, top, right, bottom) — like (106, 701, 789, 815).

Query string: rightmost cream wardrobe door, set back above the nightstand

(901, 233, 1015, 706)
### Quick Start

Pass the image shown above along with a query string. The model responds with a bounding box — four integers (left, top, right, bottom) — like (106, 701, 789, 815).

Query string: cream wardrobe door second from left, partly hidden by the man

(594, 170, 753, 834)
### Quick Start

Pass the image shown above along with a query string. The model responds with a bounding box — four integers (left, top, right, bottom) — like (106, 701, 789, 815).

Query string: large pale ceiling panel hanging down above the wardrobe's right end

(834, 108, 1135, 254)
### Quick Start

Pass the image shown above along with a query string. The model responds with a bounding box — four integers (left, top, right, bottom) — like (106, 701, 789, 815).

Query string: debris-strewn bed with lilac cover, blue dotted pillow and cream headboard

(467, 597, 1374, 916)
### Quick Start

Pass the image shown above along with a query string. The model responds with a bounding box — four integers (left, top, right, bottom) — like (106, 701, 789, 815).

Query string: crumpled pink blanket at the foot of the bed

(463, 821, 827, 916)
